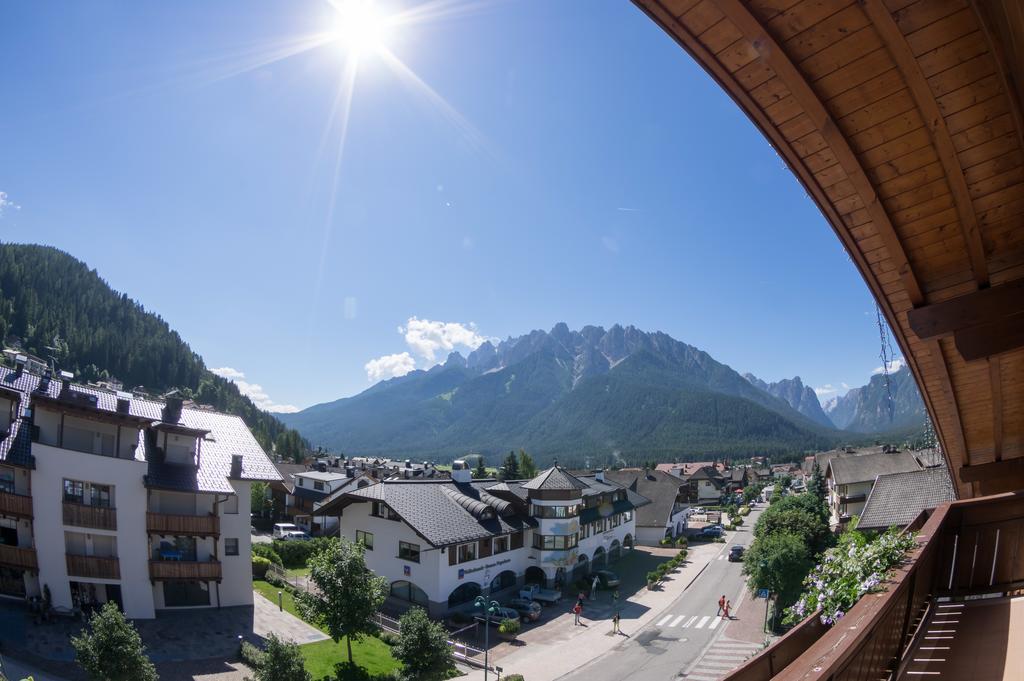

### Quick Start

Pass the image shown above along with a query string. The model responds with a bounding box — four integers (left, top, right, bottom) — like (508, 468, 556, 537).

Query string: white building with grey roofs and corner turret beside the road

(318, 462, 647, 615)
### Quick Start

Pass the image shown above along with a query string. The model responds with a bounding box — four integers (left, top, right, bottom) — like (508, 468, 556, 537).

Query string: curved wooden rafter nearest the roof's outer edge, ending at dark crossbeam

(717, 0, 925, 306)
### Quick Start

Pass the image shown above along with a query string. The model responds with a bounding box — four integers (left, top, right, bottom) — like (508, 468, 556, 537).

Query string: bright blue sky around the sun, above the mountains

(0, 0, 880, 409)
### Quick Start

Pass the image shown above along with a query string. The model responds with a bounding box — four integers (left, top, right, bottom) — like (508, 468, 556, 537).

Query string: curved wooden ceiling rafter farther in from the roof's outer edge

(860, 0, 988, 288)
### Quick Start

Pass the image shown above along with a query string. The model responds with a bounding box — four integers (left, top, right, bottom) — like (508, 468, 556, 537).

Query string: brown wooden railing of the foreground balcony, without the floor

(725, 493, 1024, 681)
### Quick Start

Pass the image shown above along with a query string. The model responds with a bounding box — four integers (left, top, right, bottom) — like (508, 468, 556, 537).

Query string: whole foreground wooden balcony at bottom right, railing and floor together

(725, 493, 1024, 681)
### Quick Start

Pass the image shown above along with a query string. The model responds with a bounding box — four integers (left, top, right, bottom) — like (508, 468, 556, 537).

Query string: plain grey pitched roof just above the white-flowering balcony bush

(857, 466, 956, 529)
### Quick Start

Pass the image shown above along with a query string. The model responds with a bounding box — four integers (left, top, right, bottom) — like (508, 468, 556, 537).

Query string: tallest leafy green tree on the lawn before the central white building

(296, 538, 388, 663)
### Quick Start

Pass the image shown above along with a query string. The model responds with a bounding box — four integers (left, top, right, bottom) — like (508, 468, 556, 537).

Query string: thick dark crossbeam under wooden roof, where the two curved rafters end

(906, 279, 1024, 340)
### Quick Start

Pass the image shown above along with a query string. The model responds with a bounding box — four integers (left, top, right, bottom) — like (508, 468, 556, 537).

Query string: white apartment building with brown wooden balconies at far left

(0, 368, 278, 619)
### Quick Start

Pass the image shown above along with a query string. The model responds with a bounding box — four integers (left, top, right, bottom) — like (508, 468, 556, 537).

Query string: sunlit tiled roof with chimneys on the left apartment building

(0, 367, 281, 494)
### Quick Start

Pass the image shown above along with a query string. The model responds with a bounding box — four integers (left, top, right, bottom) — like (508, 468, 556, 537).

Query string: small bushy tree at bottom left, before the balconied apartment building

(71, 601, 159, 681)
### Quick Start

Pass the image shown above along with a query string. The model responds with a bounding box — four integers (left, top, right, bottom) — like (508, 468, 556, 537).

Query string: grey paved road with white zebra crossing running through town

(559, 510, 761, 681)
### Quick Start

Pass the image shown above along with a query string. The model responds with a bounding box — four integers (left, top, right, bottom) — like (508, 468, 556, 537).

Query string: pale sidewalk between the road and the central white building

(462, 544, 728, 681)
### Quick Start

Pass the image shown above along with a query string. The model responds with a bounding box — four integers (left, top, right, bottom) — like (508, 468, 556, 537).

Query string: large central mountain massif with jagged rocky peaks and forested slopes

(281, 324, 929, 465)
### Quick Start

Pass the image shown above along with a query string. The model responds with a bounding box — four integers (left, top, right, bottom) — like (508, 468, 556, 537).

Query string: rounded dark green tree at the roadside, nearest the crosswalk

(743, 533, 814, 608)
